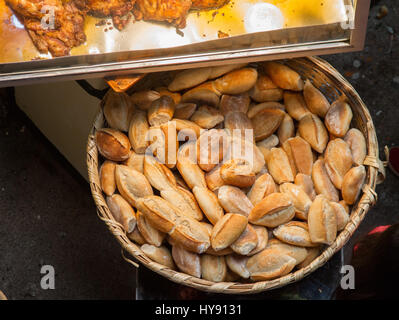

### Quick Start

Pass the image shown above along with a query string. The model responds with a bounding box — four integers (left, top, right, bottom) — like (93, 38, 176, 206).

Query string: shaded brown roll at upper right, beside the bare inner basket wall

(263, 61, 304, 91)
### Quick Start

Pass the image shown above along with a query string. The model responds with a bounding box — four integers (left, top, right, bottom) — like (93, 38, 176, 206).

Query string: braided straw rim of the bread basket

(87, 57, 379, 294)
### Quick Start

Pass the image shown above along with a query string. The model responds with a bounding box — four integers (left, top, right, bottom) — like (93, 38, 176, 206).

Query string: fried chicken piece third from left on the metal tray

(133, 0, 191, 28)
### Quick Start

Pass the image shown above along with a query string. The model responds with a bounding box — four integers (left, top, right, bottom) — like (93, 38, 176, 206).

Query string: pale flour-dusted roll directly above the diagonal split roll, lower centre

(218, 185, 253, 217)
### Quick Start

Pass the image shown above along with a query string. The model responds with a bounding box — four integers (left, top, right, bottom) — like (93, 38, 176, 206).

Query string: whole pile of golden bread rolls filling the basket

(96, 62, 366, 282)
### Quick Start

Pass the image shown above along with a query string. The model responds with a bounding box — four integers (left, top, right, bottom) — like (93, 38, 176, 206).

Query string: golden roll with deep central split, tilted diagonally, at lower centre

(211, 213, 248, 251)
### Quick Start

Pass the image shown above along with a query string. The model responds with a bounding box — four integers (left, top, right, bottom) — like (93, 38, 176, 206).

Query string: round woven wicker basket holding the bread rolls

(87, 57, 383, 294)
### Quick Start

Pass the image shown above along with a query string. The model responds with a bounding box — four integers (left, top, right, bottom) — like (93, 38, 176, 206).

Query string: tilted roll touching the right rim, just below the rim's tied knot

(341, 165, 366, 204)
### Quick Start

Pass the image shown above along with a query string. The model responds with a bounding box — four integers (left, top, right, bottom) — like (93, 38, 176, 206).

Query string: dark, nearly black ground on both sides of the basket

(0, 1, 399, 299)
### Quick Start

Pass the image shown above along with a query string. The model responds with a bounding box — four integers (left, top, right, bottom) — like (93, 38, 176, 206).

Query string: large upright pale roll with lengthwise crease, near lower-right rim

(308, 195, 337, 245)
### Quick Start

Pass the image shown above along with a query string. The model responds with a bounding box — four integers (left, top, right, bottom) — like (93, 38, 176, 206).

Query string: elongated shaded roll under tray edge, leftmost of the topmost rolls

(168, 68, 211, 91)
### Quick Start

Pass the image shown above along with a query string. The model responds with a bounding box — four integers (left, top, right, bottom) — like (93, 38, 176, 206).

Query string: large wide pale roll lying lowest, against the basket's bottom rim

(246, 247, 296, 281)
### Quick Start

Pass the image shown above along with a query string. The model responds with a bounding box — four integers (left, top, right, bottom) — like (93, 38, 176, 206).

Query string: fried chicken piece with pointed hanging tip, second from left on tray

(76, 0, 136, 30)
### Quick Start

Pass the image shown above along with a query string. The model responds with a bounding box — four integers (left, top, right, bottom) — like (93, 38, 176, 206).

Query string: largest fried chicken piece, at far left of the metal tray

(6, 0, 86, 57)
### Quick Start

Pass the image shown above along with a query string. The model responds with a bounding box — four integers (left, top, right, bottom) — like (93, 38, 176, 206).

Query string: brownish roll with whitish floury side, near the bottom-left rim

(172, 245, 201, 278)
